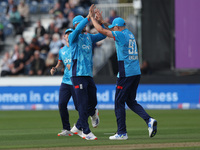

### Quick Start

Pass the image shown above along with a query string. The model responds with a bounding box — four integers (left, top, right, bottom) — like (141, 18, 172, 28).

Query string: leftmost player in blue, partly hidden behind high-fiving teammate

(50, 29, 77, 136)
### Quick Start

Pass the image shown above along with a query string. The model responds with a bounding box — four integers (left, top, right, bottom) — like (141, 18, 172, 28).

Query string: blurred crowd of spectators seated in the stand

(0, 0, 134, 76)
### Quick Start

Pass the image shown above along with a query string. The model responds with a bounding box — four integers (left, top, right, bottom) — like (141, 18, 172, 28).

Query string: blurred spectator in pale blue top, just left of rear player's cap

(49, 33, 62, 56)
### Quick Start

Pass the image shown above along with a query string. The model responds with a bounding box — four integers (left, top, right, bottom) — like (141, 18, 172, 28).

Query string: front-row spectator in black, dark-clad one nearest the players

(29, 50, 45, 75)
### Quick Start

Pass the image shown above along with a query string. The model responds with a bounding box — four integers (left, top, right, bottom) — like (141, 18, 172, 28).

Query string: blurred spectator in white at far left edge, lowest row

(1, 52, 12, 77)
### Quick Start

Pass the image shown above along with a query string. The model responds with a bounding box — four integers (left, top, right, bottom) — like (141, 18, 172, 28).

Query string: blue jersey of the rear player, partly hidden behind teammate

(58, 45, 72, 85)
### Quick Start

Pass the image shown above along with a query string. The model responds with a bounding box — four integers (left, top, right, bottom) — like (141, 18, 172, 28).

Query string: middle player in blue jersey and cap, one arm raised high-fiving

(69, 8, 106, 140)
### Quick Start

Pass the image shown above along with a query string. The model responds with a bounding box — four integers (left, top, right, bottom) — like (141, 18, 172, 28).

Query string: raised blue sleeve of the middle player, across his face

(69, 18, 89, 44)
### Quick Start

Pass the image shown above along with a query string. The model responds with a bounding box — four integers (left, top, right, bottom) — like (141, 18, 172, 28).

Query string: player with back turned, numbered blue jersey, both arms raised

(89, 5, 157, 140)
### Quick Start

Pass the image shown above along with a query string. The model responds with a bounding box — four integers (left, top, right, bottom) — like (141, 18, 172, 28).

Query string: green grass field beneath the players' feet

(0, 110, 200, 150)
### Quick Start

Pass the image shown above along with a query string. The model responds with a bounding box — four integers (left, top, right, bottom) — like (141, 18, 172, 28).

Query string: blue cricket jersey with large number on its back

(112, 29, 141, 77)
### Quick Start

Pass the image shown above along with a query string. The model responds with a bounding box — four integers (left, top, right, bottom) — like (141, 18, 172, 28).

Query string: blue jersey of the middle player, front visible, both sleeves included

(69, 18, 106, 77)
